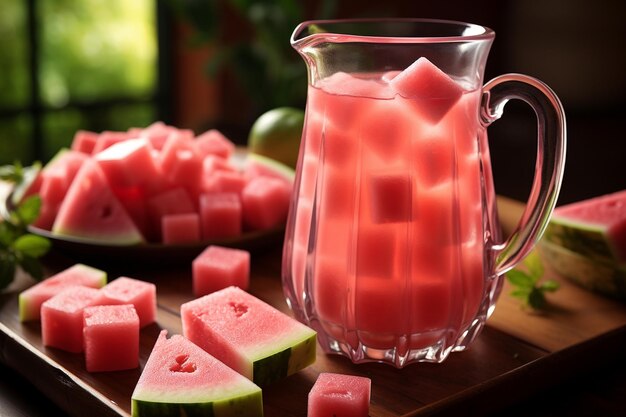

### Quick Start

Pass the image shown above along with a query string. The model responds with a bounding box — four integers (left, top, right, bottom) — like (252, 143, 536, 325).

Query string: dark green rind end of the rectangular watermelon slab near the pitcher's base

(252, 328, 317, 386)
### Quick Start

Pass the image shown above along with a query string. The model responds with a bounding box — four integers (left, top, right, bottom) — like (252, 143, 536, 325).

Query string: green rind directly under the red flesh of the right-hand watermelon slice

(543, 216, 626, 266)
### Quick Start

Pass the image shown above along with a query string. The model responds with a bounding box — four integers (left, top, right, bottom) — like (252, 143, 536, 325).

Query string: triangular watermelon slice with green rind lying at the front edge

(131, 330, 263, 417)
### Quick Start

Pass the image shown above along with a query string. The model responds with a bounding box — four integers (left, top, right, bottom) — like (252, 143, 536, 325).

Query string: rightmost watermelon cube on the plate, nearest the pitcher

(241, 176, 292, 230)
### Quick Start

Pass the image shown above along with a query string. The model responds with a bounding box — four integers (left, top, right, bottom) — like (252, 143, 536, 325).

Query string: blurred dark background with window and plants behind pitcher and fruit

(0, 0, 626, 204)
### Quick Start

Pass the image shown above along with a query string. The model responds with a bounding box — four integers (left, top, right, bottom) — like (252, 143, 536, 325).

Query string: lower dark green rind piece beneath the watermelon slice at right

(538, 240, 626, 301)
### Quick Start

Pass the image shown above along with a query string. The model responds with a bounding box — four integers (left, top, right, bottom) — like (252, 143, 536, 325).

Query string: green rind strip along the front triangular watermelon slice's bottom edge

(131, 390, 263, 417)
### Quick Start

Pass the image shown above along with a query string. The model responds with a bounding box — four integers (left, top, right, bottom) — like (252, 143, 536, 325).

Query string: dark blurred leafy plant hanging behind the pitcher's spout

(170, 0, 337, 116)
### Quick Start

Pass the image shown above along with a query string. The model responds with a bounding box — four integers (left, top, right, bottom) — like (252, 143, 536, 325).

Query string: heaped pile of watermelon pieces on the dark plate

(18, 122, 293, 245)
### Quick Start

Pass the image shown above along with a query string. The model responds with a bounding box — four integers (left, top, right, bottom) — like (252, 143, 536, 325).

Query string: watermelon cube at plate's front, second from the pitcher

(200, 193, 242, 239)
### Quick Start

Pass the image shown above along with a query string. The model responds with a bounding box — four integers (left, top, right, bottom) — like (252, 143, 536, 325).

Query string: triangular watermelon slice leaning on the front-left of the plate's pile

(52, 159, 143, 245)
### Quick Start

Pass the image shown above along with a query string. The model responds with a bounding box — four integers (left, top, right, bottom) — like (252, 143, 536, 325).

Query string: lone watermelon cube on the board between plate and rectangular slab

(192, 245, 250, 297)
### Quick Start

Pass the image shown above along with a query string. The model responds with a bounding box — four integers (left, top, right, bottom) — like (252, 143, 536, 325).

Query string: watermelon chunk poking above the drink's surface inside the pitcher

(389, 57, 463, 124)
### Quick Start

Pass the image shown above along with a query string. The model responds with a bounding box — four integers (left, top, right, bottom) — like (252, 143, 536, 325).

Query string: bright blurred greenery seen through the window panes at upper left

(0, 0, 158, 164)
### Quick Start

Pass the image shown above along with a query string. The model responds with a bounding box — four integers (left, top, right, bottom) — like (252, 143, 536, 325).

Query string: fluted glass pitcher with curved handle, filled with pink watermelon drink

(282, 19, 565, 368)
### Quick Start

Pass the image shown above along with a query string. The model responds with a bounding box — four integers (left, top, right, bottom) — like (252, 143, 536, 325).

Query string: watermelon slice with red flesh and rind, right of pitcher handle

(544, 190, 626, 267)
